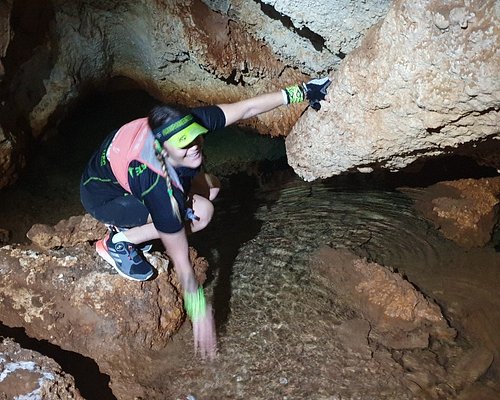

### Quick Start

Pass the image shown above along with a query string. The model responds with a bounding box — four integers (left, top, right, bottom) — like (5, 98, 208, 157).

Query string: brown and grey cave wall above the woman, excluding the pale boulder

(0, 0, 390, 187)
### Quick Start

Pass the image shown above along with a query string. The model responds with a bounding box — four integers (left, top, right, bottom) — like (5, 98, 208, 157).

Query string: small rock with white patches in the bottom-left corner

(0, 339, 84, 400)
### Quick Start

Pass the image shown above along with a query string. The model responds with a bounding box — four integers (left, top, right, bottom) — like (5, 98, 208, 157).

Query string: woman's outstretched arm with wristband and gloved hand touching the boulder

(218, 78, 331, 126)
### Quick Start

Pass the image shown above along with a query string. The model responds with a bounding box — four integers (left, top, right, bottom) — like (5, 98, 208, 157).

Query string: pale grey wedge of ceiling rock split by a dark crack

(215, 0, 390, 75)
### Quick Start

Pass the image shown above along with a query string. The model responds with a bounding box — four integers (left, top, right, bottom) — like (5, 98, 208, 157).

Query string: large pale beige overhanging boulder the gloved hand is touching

(286, 0, 500, 181)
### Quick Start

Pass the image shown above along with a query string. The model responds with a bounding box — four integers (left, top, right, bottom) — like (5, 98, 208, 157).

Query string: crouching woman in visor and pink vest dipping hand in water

(80, 78, 330, 358)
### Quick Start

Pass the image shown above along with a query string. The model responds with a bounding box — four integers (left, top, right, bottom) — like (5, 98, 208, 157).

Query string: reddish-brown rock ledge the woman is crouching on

(0, 217, 208, 398)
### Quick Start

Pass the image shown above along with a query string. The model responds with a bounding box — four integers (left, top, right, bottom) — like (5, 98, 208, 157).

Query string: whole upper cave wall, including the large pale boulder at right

(0, 0, 500, 187)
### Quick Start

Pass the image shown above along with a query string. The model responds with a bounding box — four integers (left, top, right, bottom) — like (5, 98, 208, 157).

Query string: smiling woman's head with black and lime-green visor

(148, 105, 207, 168)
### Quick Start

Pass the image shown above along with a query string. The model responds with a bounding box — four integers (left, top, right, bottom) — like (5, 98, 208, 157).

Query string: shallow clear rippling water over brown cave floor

(176, 173, 500, 399)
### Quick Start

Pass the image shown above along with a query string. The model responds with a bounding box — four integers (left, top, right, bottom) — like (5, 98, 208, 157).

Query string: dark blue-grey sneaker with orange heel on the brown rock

(95, 232, 154, 281)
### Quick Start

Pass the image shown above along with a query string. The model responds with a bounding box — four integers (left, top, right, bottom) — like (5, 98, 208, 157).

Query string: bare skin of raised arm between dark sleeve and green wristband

(218, 91, 285, 126)
